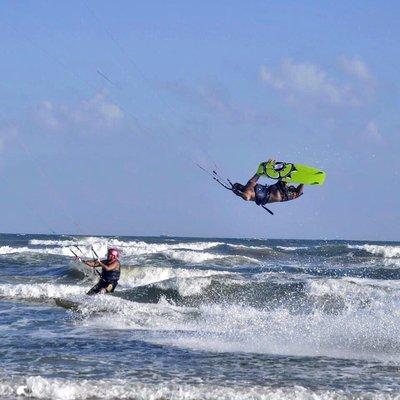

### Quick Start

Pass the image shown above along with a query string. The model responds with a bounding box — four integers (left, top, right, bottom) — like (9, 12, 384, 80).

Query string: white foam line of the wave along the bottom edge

(0, 376, 376, 400)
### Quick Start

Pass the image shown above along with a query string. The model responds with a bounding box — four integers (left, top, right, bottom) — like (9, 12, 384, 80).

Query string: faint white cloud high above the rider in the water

(34, 93, 124, 130)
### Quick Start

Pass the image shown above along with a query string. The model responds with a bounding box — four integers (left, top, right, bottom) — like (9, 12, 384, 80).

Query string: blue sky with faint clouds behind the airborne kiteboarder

(0, 1, 400, 240)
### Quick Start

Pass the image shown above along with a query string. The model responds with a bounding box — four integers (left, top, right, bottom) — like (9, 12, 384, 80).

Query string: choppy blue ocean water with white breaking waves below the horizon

(0, 234, 400, 400)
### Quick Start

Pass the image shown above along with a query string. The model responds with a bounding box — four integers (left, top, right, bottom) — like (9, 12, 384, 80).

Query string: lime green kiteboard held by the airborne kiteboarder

(257, 161, 326, 185)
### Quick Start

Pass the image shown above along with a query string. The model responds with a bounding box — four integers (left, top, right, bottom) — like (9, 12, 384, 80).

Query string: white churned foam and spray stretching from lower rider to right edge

(76, 276, 400, 363)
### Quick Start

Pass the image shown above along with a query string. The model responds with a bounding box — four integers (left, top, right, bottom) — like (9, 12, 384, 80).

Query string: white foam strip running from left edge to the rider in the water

(0, 283, 85, 299)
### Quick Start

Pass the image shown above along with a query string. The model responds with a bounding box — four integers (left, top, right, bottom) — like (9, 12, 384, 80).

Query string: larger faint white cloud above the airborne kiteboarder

(260, 60, 360, 107)
